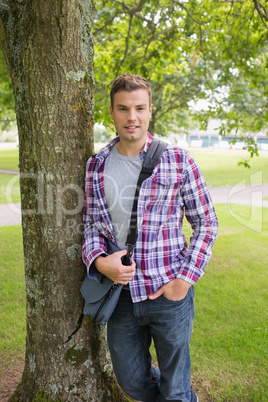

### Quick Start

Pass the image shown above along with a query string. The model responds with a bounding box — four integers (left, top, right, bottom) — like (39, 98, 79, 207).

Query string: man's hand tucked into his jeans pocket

(149, 278, 191, 301)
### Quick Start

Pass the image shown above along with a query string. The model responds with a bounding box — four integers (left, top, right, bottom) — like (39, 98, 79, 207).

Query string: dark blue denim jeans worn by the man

(107, 286, 196, 402)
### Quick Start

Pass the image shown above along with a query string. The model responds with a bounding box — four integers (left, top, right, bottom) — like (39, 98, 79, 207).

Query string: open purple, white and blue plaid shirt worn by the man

(83, 133, 218, 302)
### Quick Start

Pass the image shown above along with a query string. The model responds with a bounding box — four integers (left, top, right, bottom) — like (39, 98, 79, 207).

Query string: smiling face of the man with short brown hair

(110, 89, 153, 146)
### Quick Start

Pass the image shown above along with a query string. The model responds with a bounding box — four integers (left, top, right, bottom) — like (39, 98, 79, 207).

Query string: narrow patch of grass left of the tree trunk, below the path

(0, 226, 26, 372)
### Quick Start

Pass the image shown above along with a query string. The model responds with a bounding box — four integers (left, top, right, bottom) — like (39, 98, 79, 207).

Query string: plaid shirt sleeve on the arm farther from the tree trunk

(177, 154, 218, 284)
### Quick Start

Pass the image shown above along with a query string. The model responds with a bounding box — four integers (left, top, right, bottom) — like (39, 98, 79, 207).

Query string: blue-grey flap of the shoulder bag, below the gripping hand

(80, 276, 113, 303)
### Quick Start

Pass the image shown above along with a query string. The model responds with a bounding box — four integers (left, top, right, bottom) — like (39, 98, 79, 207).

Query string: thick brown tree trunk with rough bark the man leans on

(0, 0, 125, 402)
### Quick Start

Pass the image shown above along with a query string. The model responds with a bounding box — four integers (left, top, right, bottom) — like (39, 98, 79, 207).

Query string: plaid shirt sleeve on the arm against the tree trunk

(82, 158, 107, 281)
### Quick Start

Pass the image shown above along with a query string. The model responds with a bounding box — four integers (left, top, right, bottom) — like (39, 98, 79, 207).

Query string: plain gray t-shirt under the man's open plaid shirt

(104, 145, 142, 249)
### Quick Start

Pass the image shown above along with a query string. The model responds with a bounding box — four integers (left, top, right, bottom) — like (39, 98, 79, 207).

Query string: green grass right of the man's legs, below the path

(154, 204, 268, 402)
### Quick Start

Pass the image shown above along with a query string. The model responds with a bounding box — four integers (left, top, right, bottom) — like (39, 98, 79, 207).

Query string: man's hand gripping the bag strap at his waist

(94, 250, 136, 285)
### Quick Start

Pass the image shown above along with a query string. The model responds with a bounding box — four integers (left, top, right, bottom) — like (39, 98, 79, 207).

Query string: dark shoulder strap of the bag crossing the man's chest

(126, 138, 167, 251)
